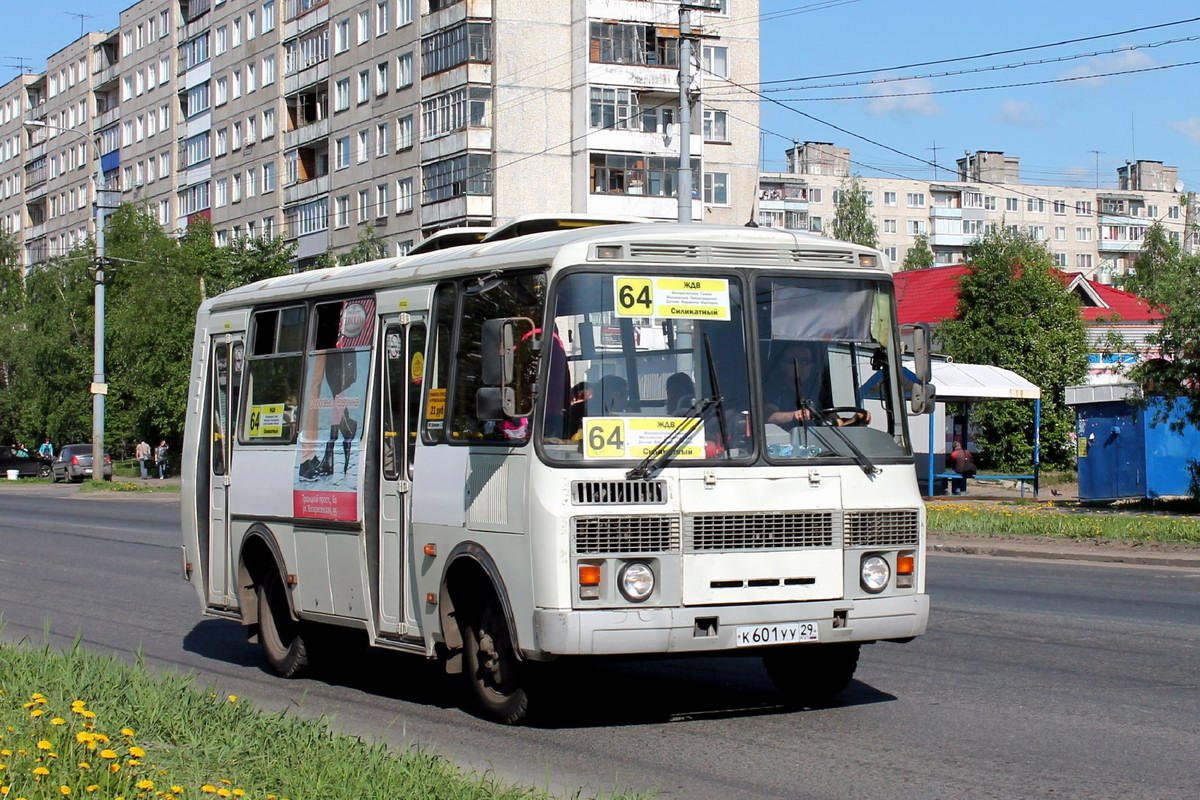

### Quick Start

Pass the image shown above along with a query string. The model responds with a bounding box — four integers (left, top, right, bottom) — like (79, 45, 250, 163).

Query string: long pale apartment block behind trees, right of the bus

(758, 142, 1200, 282)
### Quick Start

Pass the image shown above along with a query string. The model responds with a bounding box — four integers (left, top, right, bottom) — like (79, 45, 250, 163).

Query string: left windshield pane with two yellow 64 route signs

(541, 272, 754, 463)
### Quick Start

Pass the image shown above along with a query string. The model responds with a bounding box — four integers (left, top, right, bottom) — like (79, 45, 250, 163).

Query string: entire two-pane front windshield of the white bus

(540, 271, 910, 469)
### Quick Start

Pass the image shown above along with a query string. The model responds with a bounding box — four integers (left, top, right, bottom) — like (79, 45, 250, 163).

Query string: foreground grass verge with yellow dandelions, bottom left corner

(0, 640, 643, 800)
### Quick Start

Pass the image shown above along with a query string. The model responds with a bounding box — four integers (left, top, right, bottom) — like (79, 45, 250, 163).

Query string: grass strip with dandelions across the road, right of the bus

(925, 501, 1200, 545)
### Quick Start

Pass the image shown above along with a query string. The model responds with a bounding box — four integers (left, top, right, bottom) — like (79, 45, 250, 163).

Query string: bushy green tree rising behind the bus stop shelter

(937, 230, 1087, 470)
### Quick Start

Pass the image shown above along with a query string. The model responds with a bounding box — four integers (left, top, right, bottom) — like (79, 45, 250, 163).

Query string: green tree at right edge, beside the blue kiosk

(1126, 223, 1200, 428)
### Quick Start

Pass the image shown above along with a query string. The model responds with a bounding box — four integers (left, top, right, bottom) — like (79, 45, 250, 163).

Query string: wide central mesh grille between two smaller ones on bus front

(684, 511, 834, 553)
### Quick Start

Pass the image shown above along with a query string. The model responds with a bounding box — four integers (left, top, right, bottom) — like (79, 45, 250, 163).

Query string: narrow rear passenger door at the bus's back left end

(206, 333, 242, 608)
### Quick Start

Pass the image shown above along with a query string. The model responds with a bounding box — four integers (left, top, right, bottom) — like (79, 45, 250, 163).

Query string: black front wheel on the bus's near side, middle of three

(462, 597, 529, 724)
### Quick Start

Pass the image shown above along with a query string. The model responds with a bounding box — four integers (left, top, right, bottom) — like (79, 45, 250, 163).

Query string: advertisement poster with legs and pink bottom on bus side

(293, 297, 374, 522)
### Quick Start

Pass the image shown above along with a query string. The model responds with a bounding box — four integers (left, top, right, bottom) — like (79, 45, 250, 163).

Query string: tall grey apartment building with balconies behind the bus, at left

(0, 0, 758, 266)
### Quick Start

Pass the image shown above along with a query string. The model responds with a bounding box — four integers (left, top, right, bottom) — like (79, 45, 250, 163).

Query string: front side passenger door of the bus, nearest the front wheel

(377, 314, 426, 636)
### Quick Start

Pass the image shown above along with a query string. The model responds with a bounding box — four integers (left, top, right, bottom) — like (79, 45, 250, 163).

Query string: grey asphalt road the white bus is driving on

(0, 486, 1200, 800)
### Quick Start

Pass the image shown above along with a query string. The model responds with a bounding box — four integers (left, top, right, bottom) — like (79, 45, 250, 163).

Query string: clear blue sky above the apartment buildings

(0, 0, 1200, 190)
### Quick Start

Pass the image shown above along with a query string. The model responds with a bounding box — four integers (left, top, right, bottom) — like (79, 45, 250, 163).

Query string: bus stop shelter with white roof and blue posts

(906, 361, 1042, 497)
